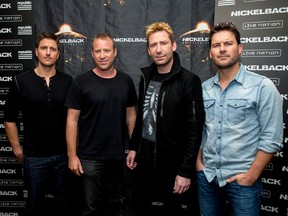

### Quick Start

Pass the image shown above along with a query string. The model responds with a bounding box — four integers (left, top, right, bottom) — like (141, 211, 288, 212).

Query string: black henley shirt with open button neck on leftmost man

(4, 70, 72, 156)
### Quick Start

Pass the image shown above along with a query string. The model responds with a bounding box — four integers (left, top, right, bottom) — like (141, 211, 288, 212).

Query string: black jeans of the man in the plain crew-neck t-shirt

(81, 159, 124, 216)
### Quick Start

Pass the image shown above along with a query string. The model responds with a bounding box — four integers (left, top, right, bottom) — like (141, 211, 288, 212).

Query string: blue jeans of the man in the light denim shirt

(197, 171, 262, 216)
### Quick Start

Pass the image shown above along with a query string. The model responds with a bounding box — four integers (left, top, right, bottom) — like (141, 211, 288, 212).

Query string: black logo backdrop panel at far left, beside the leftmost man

(0, 0, 35, 216)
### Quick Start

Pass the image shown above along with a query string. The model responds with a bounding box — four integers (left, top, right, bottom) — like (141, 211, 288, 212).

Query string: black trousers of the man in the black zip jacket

(132, 158, 199, 216)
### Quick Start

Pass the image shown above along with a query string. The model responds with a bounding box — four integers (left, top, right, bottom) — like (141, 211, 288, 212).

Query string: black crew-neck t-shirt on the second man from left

(65, 70, 137, 160)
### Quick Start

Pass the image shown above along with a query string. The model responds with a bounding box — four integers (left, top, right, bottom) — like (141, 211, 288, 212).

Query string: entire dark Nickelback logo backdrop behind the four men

(0, 0, 288, 216)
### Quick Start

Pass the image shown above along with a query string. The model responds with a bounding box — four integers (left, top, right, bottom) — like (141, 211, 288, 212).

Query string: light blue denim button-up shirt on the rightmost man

(201, 65, 283, 187)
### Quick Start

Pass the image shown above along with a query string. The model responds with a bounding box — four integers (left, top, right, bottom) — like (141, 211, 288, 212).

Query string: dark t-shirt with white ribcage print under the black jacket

(142, 73, 170, 142)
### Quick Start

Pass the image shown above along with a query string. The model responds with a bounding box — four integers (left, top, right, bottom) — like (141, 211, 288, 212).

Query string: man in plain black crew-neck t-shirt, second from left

(65, 34, 137, 216)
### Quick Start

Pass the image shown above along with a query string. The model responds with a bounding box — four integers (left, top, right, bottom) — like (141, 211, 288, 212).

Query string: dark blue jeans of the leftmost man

(23, 154, 68, 216)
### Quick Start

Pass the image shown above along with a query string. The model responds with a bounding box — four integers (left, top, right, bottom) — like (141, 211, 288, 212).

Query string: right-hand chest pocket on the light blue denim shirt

(227, 99, 248, 124)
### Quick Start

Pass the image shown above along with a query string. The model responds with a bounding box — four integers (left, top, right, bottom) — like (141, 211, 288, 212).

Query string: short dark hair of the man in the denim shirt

(209, 22, 241, 46)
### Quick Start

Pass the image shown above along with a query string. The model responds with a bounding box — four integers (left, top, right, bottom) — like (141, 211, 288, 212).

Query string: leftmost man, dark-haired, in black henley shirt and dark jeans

(4, 33, 72, 216)
